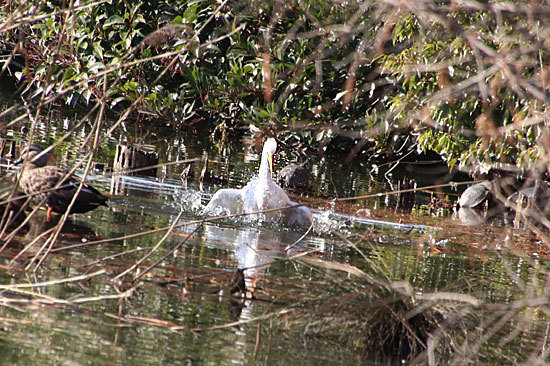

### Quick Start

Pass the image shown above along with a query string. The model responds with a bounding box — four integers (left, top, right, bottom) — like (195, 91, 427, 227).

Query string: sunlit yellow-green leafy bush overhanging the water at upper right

(377, 5, 548, 169)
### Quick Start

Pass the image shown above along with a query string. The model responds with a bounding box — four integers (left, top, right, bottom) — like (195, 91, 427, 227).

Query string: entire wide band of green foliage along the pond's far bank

(0, 0, 548, 170)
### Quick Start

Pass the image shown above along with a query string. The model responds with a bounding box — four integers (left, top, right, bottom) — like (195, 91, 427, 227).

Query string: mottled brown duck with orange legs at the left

(14, 145, 108, 221)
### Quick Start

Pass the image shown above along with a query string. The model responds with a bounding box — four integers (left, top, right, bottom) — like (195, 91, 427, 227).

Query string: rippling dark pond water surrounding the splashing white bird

(0, 111, 549, 365)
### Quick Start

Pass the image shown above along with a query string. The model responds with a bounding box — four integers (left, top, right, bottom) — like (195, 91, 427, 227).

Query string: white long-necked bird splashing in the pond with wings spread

(205, 138, 312, 226)
